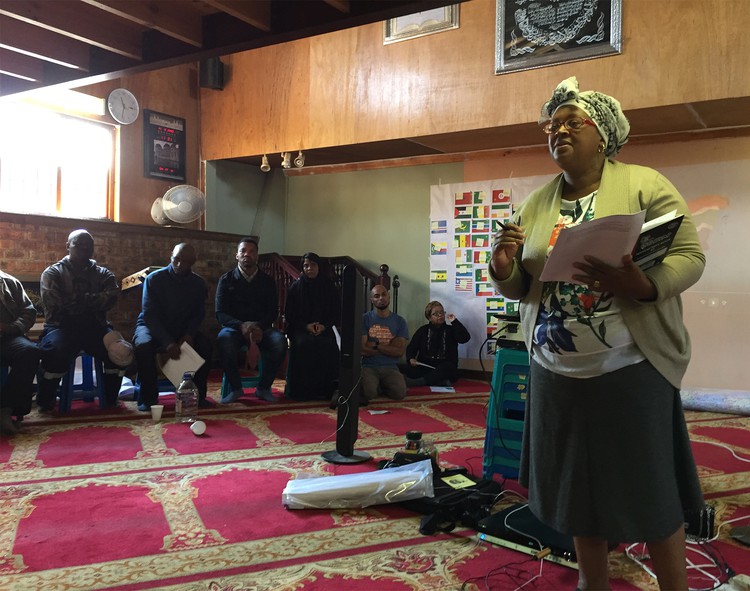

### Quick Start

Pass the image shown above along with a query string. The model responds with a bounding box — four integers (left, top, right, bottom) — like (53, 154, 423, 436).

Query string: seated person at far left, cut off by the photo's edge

(0, 271, 39, 435)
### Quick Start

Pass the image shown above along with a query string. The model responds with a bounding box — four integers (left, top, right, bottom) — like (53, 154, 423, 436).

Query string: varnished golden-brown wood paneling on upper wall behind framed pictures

(202, 0, 750, 160)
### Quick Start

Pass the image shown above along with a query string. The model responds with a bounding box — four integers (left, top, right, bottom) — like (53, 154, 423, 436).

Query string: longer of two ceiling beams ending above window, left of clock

(0, 13, 91, 72)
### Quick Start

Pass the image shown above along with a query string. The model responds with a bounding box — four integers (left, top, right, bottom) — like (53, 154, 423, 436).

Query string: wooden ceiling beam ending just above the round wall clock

(0, 0, 143, 60)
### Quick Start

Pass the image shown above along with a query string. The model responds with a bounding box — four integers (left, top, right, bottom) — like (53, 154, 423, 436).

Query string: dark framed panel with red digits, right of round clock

(143, 110, 185, 181)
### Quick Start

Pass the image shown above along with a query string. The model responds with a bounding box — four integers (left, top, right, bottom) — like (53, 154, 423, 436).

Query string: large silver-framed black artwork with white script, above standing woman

(495, 0, 622, 74)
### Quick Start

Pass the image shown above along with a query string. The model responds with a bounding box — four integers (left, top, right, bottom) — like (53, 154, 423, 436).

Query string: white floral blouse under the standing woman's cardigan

(533, 191, 645, 378)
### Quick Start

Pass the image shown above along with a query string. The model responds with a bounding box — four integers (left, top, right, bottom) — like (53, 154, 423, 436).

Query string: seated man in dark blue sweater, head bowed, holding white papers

(133, 244, 212, 412)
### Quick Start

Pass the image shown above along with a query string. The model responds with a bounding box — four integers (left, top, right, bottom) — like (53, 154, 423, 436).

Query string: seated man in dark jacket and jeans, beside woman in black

(216, 238, 287, 404)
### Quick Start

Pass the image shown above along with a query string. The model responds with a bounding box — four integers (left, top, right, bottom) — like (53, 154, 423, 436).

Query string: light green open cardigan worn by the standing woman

(490, 160, 706, 388)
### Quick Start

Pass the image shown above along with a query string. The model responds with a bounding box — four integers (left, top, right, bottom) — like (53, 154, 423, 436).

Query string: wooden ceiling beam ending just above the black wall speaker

(81, 0, 203, 47)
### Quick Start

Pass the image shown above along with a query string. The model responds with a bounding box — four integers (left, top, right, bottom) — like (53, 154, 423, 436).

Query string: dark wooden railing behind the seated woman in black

(258, 252, 399, 330)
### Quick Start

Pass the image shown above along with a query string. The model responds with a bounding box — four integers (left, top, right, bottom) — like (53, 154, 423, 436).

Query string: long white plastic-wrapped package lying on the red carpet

(281, 460, 435, 509)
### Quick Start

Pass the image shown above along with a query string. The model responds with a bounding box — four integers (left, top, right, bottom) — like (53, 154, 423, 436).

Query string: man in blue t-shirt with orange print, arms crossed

(361, 285, 409, 405)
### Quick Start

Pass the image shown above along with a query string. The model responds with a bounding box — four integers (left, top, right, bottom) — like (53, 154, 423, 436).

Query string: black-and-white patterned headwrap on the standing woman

(540, 76, 630, 156)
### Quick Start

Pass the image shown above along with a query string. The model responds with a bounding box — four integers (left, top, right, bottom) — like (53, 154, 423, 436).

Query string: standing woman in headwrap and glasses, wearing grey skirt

(490, 78, 705, 591)
